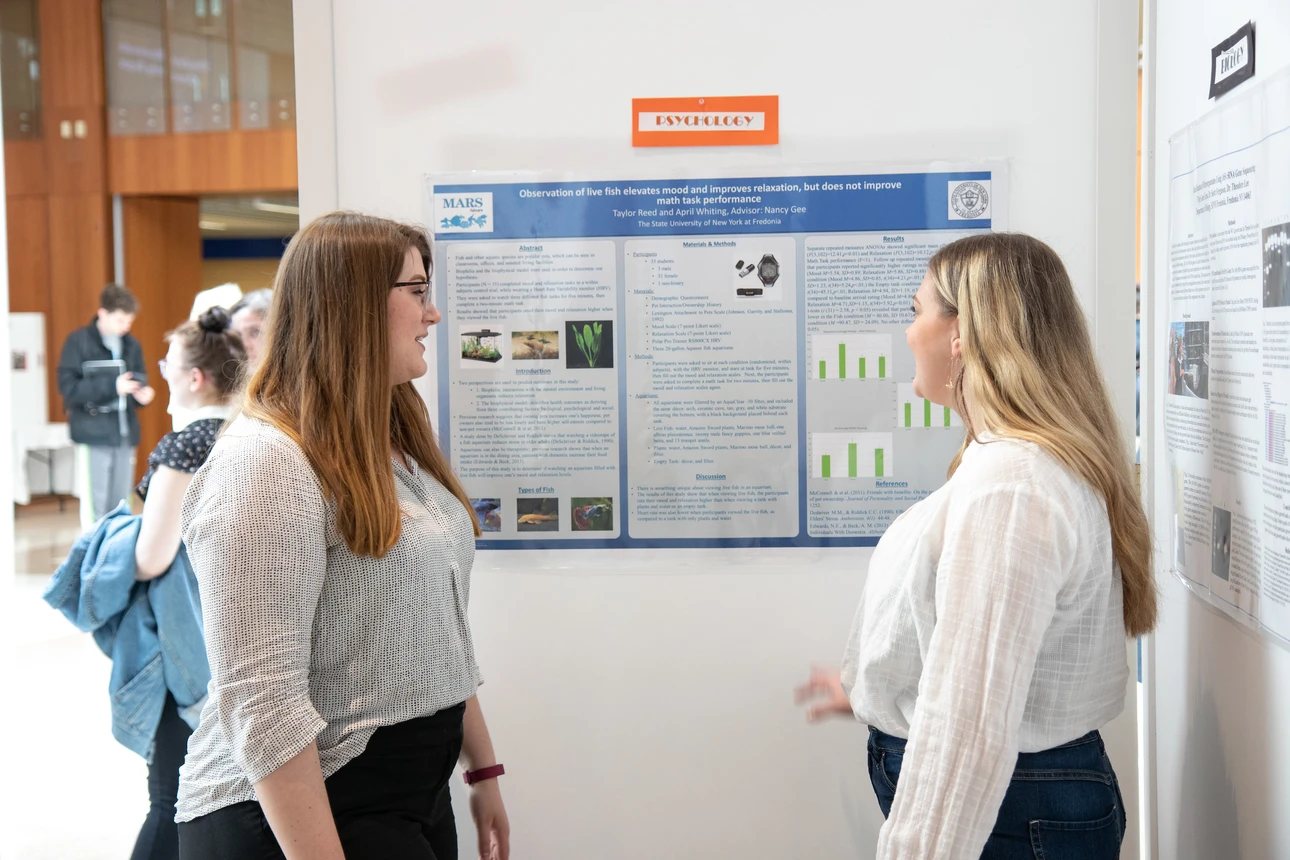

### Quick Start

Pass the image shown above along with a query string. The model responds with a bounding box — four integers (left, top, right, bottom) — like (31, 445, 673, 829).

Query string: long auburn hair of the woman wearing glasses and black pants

(243, 211, 480, 558)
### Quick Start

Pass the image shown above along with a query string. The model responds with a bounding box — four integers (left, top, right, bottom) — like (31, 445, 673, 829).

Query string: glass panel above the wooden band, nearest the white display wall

(233, 0, 295, 129)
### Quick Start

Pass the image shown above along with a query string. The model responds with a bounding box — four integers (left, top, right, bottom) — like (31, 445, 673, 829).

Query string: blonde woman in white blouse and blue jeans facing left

(799, 233, 1156, 860)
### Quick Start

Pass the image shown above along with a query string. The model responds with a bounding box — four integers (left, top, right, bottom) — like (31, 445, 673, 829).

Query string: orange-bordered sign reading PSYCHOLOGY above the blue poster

(632, 95, 779, 146)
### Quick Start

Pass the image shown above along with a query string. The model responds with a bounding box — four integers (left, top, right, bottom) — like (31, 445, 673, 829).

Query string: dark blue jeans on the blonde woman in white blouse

(869, 726, 1126, 860)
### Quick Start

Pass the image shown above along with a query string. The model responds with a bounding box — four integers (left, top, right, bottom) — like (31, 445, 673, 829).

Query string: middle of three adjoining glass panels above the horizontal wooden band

(169, 0, 232, 133)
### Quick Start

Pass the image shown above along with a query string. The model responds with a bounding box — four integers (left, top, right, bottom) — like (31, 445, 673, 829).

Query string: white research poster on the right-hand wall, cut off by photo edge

(1156, 67, 1290, 640)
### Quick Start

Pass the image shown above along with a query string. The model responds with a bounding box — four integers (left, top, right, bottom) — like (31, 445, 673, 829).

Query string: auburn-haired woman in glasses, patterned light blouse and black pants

(177, 213, 508, 860)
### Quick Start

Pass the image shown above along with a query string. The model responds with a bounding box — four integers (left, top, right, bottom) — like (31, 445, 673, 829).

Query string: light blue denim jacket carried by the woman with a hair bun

(44, 502, 210, 762)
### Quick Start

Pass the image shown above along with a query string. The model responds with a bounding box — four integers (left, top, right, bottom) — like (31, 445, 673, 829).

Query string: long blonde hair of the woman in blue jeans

(928, 233, 1156, 636)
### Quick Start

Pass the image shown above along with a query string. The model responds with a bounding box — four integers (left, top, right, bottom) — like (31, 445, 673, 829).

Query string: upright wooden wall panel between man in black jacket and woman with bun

(121, 197, 201, 477)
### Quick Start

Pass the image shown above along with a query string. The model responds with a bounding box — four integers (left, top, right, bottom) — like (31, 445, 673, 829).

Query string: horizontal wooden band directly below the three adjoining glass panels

(107, 129, 297, 195)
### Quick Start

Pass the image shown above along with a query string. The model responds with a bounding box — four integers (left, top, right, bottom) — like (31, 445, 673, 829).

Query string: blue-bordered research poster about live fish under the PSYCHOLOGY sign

(426, 161, 1007, 549)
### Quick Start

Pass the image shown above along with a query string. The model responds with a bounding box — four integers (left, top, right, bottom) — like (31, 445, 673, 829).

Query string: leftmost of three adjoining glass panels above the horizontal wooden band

(103, 0, 166, 134)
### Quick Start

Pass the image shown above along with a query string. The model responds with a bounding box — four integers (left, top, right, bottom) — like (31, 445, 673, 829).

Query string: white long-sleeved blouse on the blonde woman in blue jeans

(842, 437, 1129, 860)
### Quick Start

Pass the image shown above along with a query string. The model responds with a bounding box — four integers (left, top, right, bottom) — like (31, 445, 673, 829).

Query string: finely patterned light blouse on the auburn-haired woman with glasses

(175, 416, 480, 821)
